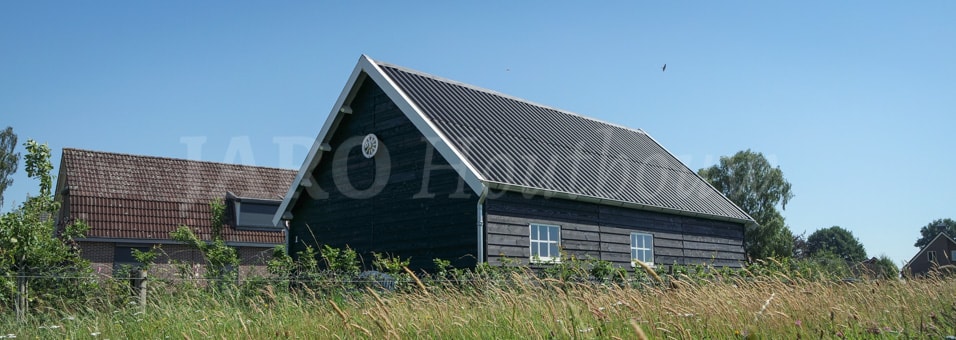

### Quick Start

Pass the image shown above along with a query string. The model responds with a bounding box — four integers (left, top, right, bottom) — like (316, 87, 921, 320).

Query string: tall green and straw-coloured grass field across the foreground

(0, 266, 956, 339)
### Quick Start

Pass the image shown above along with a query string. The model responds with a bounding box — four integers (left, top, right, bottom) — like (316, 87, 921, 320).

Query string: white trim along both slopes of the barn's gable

(272, 55, 484, 225)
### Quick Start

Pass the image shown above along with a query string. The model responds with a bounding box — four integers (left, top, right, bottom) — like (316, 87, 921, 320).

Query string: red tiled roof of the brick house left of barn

(57, 148, 296, 243)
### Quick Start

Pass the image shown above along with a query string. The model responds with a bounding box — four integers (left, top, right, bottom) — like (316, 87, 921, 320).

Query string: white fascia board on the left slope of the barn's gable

(272, 55, 369, 225)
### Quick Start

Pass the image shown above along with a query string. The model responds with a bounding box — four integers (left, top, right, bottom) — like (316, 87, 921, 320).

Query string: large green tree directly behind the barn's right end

(698, 149, 794, 259)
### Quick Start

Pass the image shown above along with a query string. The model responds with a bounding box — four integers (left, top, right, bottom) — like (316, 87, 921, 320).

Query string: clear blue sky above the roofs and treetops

(0, 1, 956, 264)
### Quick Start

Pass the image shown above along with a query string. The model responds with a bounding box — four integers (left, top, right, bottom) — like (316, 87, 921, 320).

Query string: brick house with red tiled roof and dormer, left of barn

(56, 148, 295, 275)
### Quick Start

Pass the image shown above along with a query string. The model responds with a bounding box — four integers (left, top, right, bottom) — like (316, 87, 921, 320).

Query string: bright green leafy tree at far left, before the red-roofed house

(0, 140, 88, 320)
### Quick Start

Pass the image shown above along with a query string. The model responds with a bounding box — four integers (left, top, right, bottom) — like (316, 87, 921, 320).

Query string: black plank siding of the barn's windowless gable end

(289, 79, 478, 269)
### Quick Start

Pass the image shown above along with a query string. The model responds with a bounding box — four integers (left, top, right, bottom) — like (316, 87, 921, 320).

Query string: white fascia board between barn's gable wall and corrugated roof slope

(359, 55, 485, 194)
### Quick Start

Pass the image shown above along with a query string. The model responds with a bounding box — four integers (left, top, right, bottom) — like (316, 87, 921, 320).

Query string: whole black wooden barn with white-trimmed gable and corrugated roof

(275, 56, 754, 269)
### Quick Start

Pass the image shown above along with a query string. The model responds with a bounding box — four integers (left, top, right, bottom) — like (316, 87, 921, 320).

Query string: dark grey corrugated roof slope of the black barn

(379, 63, 752, 220)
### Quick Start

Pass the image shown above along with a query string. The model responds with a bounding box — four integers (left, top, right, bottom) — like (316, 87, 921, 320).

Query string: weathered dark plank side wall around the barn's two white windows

(485, 193, 744, 267)
